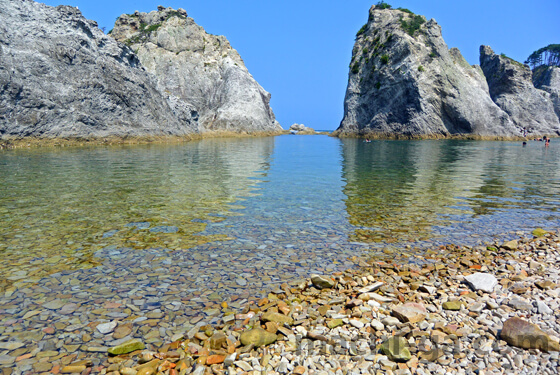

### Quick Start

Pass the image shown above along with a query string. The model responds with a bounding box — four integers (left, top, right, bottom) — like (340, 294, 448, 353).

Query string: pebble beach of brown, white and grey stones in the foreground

(0, 229, 560, 375)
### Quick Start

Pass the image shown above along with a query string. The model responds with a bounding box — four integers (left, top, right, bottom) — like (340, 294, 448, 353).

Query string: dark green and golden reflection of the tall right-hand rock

(342, 139, 558, 242)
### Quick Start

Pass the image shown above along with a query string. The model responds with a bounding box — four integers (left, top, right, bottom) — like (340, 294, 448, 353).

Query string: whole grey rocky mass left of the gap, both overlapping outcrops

(0, 0, 282, 139)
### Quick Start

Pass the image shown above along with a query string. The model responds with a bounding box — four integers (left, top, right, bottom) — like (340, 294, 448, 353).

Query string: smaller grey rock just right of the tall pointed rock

(480, 46, 560, 136)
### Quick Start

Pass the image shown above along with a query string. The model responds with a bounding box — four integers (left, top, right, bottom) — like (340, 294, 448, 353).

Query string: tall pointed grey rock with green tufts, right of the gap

(335, 6, 557, 137)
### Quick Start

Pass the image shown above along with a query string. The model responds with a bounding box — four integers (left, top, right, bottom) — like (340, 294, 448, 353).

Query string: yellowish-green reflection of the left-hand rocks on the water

(0, 137, 274, 289)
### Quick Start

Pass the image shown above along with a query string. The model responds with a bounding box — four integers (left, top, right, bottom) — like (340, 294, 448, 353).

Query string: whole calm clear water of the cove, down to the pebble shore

(0, 136, 560, 368)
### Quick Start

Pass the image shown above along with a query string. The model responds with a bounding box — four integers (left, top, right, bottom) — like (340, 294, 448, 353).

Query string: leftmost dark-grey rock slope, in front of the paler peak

(0, 0, 198, 137)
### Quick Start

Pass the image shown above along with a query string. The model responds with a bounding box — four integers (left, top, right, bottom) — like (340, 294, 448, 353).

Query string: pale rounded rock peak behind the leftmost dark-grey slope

(111, 6, 282, 132)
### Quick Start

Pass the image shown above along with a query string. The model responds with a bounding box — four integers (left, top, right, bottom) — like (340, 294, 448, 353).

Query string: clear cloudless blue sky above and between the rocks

(43, 0, 560, 130)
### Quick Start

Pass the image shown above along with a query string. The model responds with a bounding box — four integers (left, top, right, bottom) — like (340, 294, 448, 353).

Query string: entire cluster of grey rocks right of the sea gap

(334, 2, 560, 138)
